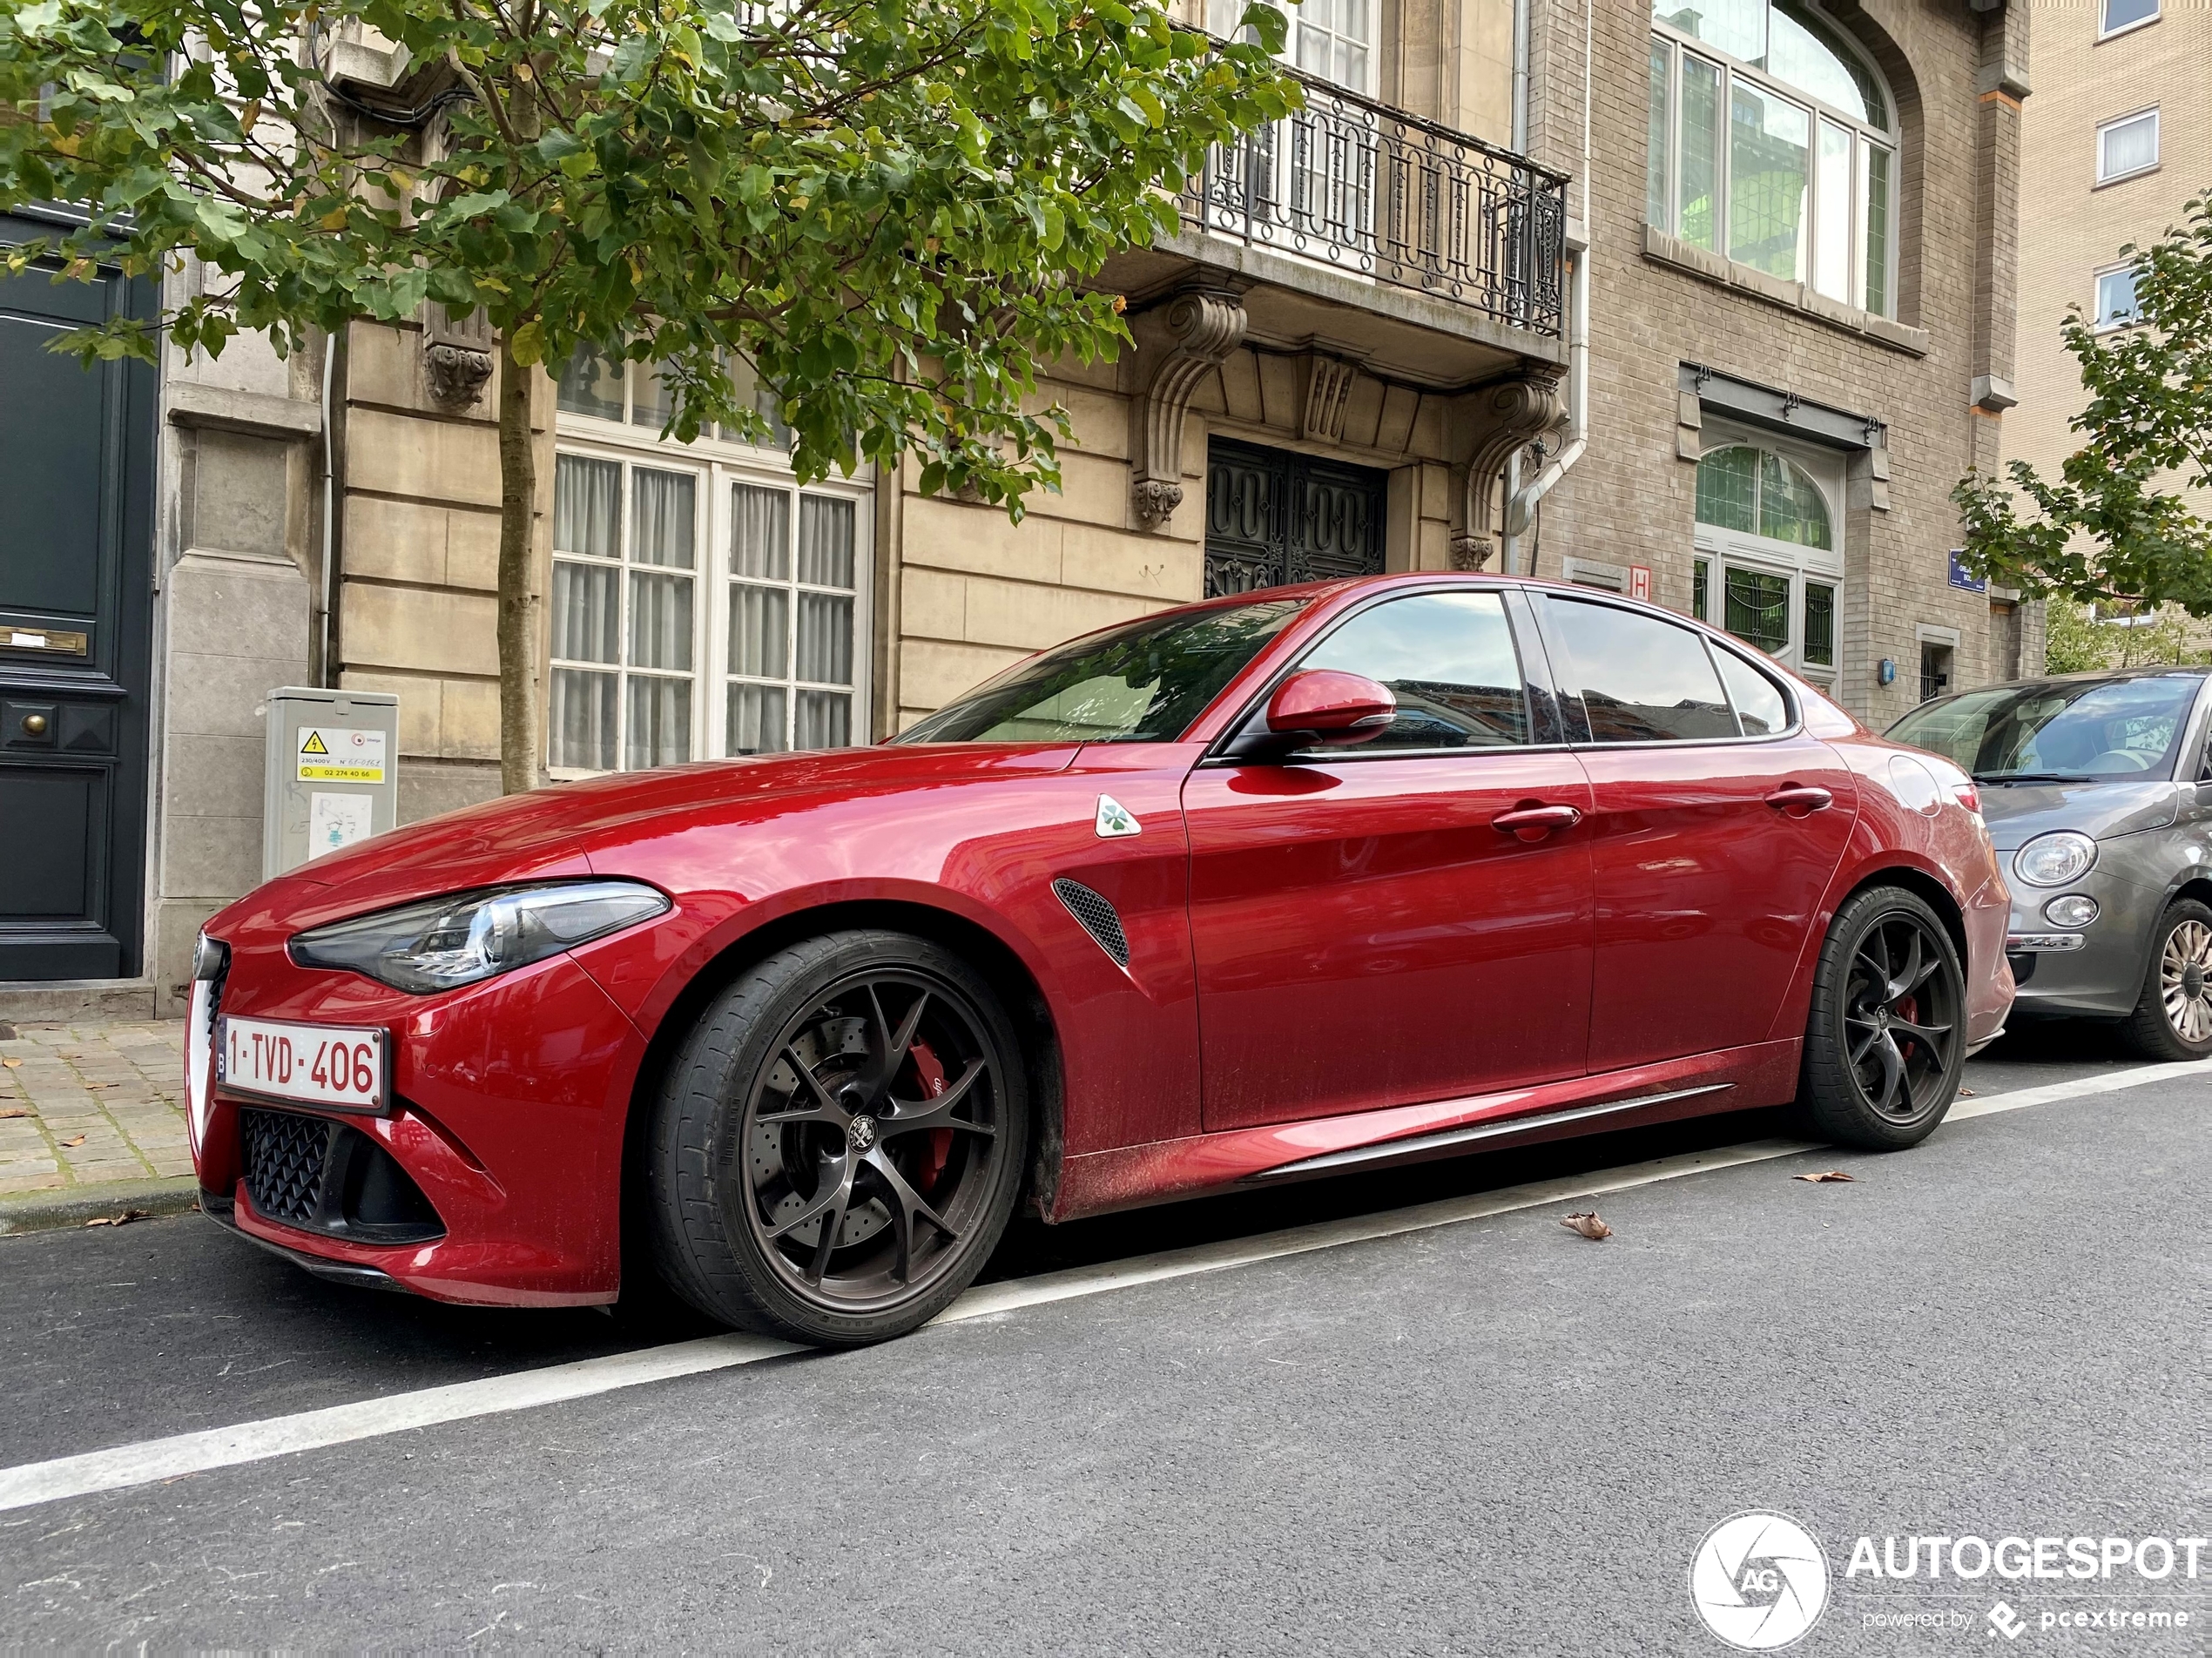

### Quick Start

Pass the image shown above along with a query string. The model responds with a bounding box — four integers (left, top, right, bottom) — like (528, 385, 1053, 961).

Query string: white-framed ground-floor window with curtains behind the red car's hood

(546, 352, 873, 776)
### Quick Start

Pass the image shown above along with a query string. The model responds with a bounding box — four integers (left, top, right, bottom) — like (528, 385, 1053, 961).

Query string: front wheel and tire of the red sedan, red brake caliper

(646, 931, 1028, 1346)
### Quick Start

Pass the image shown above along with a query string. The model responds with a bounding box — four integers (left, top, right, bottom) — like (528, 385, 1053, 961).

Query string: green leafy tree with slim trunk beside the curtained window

(0, 0, 1296, 792)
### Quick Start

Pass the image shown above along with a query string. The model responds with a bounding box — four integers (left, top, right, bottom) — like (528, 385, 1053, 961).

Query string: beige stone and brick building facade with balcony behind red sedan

(0, 0, 2037, 1006)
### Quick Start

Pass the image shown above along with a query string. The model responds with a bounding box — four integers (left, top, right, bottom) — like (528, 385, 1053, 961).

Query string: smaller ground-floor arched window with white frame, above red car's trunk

(1690, 442, 1843, 685)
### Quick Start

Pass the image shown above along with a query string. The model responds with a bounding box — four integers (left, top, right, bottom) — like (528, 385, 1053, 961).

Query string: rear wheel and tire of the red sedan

(1798, 886, 1966, 1152)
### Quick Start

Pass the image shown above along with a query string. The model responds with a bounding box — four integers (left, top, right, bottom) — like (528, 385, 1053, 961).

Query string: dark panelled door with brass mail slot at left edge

(0, 214, 155, 980)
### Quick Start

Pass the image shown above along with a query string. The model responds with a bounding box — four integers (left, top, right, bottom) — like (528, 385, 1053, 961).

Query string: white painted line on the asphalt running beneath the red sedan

(0, 1059, 2212, 1512)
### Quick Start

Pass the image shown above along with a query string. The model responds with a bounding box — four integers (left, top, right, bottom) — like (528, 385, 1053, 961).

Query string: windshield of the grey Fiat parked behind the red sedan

(1889, 674, 2203, 783)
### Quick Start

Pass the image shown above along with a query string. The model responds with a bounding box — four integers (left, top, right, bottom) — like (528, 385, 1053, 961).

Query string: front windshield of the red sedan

(896, 599, 1305, 743)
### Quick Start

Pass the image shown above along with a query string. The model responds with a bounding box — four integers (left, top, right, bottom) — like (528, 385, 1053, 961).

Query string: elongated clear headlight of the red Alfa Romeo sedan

(292, 880, 672, 994)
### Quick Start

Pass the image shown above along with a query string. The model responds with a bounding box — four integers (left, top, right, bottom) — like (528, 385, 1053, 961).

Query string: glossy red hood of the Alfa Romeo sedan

(210, 743, 1080, 933)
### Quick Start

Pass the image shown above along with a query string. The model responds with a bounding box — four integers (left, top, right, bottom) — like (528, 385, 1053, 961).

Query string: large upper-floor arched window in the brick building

(1646, 0, 1898, 316)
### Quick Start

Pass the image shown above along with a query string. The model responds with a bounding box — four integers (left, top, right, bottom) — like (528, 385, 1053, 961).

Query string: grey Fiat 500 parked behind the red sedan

(1889, 668, 2212, 1059)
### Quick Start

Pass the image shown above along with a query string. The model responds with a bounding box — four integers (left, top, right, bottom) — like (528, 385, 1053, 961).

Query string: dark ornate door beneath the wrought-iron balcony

(1205, 438, 1389, 599)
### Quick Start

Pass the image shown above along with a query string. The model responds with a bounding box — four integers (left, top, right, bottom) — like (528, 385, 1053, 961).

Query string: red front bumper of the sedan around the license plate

(188, 928, 646, 1306)
